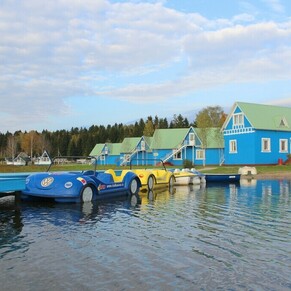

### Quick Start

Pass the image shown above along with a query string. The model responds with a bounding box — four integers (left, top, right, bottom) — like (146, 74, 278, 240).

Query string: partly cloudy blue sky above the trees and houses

(0, 0, 291, 133)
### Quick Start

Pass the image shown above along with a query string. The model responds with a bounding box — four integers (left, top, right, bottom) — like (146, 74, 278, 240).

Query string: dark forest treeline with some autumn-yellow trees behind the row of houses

(0, 114, 195, 160)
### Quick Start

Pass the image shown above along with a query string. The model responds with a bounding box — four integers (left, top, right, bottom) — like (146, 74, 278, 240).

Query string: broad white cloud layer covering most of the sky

(0, 0, 291, 130)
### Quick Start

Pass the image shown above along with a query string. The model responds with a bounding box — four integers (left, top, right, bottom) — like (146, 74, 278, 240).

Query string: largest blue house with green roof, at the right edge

(222, 102, 291, 165)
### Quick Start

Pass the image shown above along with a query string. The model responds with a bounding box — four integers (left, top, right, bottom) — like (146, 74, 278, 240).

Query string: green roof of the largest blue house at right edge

(234, 102, 291, 131)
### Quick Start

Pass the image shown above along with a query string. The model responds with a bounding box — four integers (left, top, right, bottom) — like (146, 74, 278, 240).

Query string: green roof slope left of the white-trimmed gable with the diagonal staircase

(151, 128, 190, 149)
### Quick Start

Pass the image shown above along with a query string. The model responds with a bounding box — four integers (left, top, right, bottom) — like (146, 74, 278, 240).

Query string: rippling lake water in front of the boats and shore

(0, 180, 291, 290)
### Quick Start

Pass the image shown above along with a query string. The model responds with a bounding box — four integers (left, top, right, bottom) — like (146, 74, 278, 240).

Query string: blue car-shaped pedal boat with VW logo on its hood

(21, 156, 141, 202)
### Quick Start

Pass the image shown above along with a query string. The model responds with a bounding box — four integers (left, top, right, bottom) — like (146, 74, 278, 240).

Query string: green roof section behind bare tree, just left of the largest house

(195, 127, 224, 149)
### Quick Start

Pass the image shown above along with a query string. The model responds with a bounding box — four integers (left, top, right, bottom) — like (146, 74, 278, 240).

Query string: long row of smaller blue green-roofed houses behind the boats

(90, 127, 224, 166)
